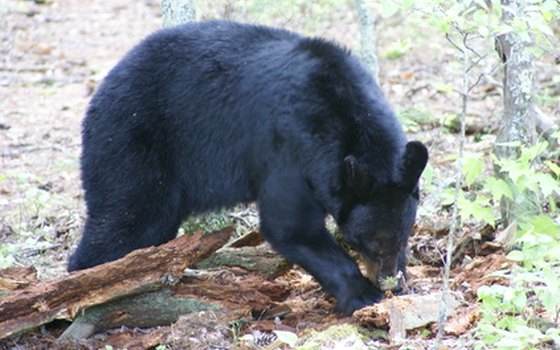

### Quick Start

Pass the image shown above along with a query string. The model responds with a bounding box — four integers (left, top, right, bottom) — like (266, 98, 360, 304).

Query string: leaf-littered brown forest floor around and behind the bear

(0, 0, 560, 349)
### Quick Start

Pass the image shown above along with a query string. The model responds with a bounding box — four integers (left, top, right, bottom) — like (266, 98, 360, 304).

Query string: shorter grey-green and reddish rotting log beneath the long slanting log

(60, 273, 288, 340)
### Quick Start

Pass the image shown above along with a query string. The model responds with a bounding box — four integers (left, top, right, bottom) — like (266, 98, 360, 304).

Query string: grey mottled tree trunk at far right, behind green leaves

(494, 0, 536, 226)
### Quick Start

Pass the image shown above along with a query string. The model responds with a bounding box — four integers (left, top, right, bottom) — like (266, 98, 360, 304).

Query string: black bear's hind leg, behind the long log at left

(68, 176, 182, 271)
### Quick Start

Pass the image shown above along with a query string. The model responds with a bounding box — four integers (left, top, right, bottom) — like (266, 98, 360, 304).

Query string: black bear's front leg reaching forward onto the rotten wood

(259, 169, 383, 314)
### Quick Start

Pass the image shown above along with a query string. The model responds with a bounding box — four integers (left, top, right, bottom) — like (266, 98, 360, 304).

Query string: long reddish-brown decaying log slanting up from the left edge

(0, 228, 233, 338)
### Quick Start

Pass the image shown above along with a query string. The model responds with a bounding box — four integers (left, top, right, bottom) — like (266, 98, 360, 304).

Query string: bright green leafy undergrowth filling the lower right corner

(470, 142, 560, 349)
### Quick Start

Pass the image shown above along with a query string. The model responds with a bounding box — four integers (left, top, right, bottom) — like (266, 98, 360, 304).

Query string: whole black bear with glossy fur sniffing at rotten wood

(68, 21, 428, 313)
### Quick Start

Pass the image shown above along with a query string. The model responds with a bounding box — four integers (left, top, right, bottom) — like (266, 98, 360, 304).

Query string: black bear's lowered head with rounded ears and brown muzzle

(337, 141, 428, 286)
